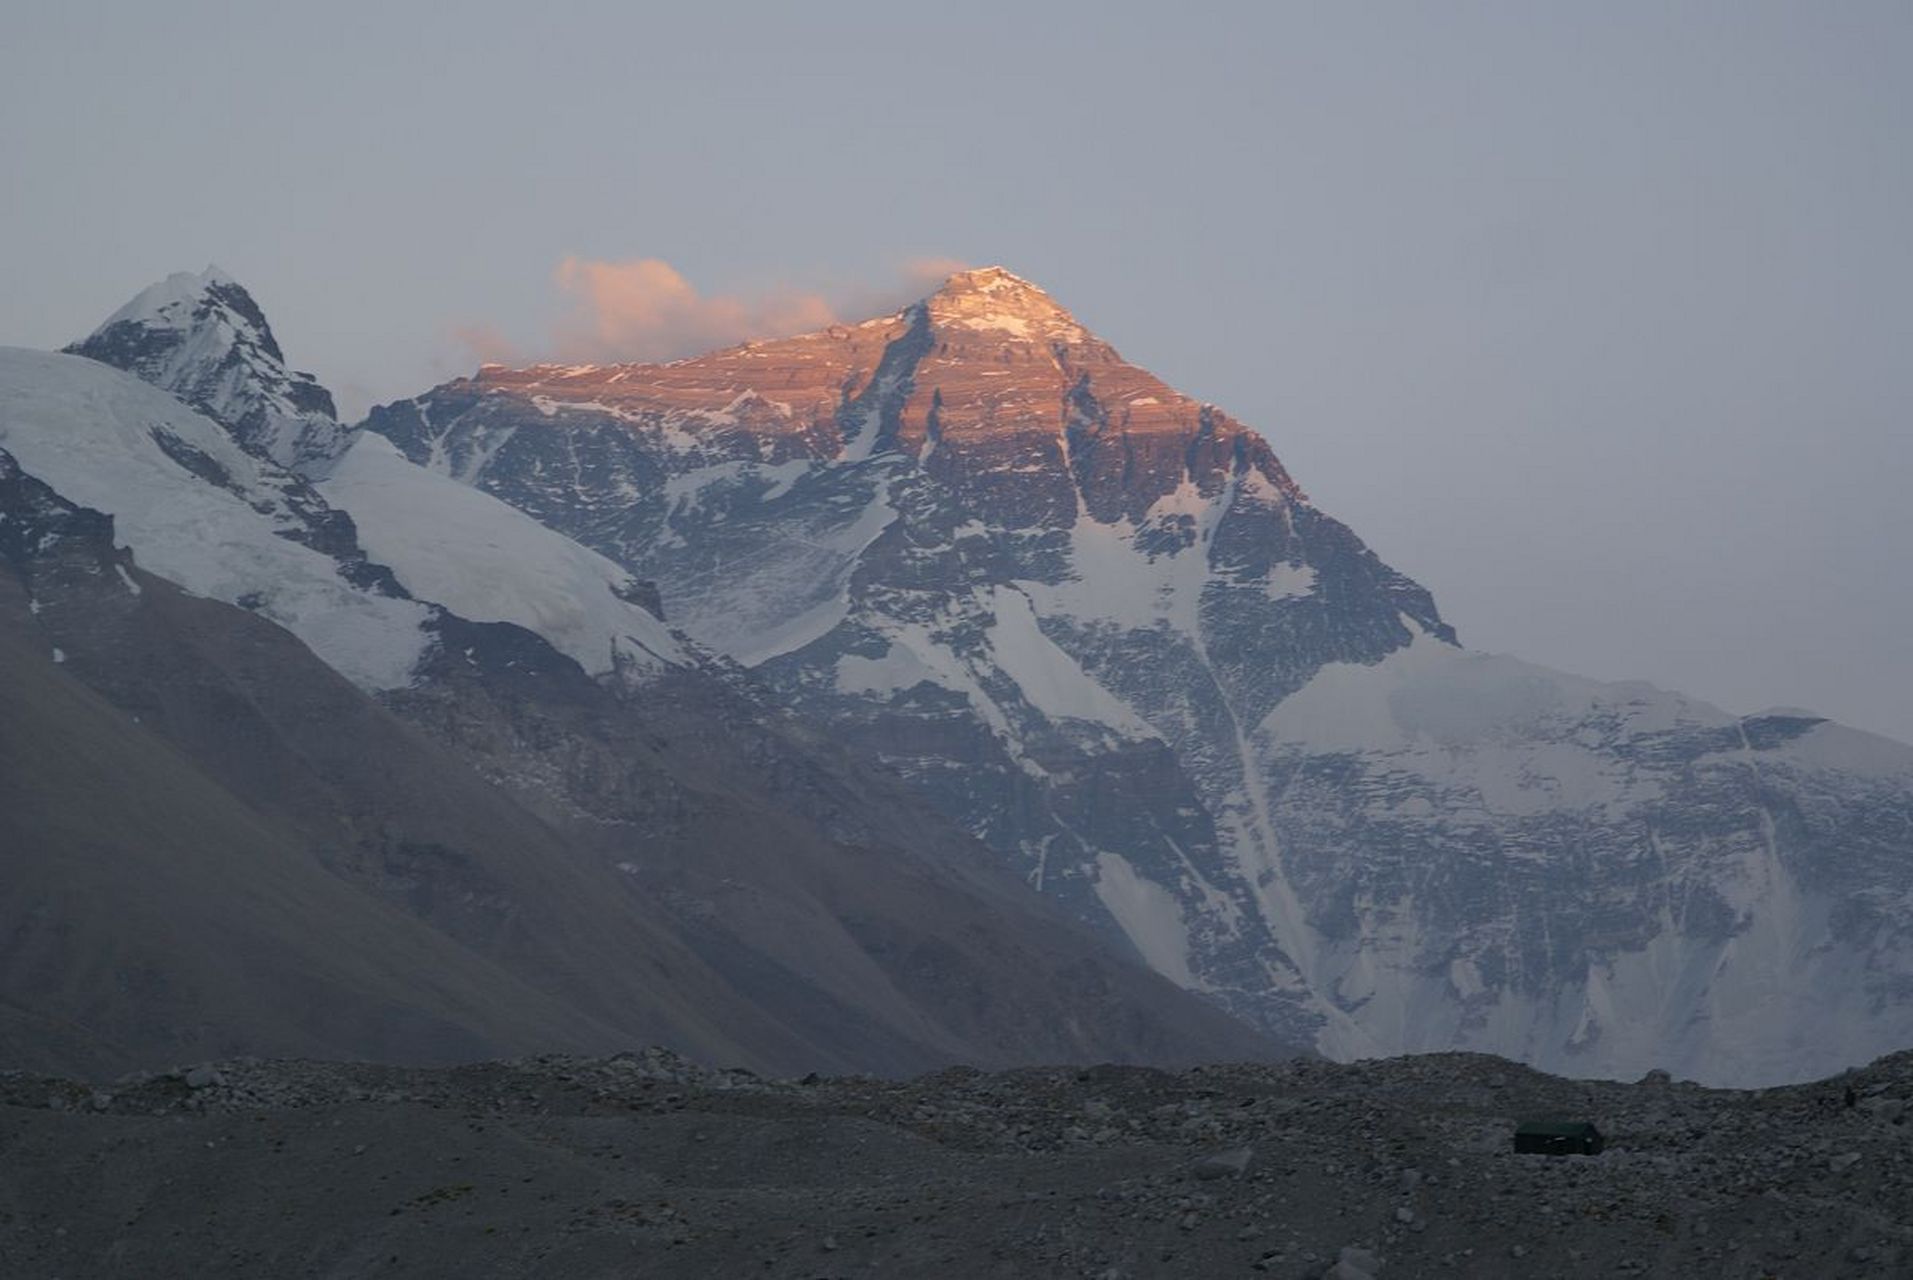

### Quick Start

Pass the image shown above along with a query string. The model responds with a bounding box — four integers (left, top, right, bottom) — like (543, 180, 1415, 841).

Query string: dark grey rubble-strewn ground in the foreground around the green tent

(0, 1050, 1913, 1280)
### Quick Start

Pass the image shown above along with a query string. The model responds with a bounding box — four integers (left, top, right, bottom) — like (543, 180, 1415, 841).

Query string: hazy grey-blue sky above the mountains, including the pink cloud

(0, 0, 1913, 740)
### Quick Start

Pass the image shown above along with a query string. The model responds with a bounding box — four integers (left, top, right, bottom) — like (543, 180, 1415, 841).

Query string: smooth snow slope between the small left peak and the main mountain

(318, 434, 689, 675)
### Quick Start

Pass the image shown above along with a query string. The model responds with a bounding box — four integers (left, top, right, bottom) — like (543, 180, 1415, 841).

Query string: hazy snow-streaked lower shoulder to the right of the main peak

(1255, 639, 1913, 1085)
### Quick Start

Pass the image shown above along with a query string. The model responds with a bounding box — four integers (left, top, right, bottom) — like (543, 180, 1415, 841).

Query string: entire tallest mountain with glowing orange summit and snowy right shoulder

(380, 268, 1913, 1081)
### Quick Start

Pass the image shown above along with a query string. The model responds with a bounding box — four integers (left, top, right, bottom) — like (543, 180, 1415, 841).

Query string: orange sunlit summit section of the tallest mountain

(449, 268, 1295, 526)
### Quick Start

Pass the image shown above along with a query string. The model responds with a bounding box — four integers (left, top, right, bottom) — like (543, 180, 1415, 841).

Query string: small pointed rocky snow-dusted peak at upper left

(67, 266, 350, 478)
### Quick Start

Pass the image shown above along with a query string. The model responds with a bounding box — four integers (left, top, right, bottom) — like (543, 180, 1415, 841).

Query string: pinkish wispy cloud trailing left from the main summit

(451, 254, 962, 364)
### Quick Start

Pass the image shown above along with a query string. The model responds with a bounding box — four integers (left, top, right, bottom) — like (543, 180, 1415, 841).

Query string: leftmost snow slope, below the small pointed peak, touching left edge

(0, 348, 430, 689)
